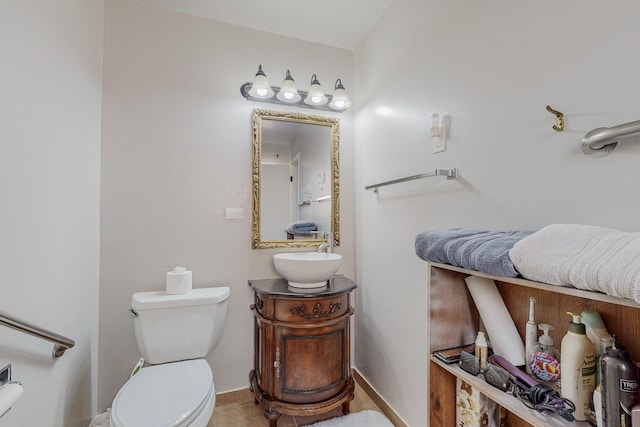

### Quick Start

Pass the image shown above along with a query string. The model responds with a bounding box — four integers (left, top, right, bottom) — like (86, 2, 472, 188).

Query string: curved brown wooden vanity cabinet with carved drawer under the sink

(249, 276, 356, 427)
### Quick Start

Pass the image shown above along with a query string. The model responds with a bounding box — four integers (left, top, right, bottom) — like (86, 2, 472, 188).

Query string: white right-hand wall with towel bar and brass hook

(354, 0, 640, 427)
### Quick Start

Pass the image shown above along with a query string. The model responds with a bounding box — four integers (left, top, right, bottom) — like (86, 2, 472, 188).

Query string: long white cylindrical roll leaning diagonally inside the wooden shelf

(464, 276, 525, 366)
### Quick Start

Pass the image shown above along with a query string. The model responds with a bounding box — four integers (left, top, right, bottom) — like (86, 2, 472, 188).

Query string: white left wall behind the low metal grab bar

(0, 0, 103, 427)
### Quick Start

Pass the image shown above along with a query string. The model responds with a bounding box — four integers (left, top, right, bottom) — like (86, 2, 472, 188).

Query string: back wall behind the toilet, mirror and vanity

(98, 0, 355, 409)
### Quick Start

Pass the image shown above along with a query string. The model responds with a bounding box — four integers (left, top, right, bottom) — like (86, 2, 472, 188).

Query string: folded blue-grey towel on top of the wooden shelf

(415, 228, 533, 277)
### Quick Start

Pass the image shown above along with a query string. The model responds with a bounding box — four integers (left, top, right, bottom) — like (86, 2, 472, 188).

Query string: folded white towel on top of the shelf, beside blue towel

(509, 224, 640, 303)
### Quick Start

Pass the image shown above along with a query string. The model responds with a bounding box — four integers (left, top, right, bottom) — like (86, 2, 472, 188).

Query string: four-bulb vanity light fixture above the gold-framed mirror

(240, 65, 351, 113)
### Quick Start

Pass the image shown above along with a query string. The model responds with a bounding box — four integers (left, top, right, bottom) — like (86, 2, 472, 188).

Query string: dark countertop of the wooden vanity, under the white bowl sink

(249, 274, 358, 298)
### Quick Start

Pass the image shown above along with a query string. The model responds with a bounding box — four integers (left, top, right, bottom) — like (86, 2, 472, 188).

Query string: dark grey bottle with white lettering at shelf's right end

(600, 335, 638, 427)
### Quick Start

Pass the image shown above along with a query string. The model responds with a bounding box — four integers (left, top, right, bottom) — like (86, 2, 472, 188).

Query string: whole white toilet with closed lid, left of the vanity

(110, 287, 230, 427)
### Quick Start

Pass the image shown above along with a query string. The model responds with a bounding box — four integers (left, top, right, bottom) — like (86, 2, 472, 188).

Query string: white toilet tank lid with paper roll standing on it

(131, 286, 231, 310)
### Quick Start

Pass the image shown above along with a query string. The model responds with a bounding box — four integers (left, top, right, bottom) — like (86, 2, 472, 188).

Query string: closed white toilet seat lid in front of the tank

(111, 359, 215, 427)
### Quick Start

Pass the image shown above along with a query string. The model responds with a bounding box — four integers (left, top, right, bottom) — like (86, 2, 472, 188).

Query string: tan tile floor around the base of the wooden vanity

(207, 383, 382, 427)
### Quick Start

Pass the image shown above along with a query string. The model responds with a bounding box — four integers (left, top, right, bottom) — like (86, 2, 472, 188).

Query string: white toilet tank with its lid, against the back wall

(131, 286, 230, 364)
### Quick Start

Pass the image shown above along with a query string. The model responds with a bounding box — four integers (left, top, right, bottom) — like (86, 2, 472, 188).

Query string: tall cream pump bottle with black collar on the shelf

(560, 312, 596, 421)
